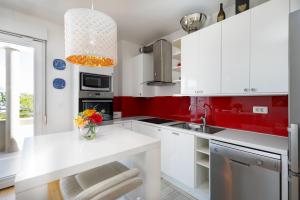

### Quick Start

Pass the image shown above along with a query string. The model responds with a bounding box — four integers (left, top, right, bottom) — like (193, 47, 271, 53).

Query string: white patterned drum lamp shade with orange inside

(65, 8, 117, 67)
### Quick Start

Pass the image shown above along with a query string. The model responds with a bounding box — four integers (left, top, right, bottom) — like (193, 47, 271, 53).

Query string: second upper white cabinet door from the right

(221, 11, 250, 94)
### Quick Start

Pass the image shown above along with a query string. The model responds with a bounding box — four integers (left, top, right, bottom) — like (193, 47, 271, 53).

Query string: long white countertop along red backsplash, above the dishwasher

(128, 116, 288, 156)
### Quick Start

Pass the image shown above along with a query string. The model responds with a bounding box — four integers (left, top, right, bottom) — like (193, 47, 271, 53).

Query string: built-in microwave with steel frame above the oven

(80, 72, 112, 92)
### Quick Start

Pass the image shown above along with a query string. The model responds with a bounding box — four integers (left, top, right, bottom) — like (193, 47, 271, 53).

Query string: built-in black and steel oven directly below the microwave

(79, 91, 113, 121)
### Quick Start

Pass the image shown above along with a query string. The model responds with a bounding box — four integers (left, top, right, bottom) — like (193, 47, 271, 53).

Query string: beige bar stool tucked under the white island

(59, 162, 143, 200)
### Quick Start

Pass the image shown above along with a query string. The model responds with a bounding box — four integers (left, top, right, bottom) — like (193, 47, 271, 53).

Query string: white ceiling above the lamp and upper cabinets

(0, 0, 232, 44)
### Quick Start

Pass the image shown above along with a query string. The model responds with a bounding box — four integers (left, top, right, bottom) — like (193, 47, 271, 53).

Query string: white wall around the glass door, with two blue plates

(0, 7, 73, 135)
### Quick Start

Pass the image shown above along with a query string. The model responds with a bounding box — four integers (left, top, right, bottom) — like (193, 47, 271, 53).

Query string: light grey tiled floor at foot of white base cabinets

(160, 179, 196, 200)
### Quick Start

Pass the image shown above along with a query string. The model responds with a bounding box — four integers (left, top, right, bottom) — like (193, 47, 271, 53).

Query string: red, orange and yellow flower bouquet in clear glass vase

(75, 108, 103, 140)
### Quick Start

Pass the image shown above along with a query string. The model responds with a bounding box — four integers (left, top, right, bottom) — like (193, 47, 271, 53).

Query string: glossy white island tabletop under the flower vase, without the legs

(15, 125, 160, 193)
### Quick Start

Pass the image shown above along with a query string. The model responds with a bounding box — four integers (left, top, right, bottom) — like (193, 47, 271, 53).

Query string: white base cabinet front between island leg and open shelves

(161, 129, 195, 188)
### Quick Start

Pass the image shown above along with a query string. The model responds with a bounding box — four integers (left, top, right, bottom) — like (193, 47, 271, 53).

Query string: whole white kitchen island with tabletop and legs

(15, 125, 160, 200)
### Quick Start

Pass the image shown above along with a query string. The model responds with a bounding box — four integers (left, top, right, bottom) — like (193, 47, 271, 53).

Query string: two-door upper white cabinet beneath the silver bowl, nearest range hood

(181, 23, 221, 95)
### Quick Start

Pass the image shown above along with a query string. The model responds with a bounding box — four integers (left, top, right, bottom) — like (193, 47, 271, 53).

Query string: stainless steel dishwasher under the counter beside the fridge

(210, 141, 281, 200)
